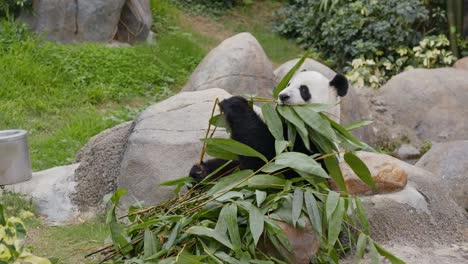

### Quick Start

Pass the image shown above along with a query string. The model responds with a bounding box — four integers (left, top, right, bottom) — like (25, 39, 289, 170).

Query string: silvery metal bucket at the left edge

(0, 130, 32, 185)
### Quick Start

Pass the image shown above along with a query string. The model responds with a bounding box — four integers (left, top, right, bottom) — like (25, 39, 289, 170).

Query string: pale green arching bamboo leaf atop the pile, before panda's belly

(275, 152, 329, 178)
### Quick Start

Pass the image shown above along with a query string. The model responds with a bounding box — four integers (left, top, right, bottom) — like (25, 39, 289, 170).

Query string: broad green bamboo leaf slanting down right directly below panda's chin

(292, 105, 336, 142)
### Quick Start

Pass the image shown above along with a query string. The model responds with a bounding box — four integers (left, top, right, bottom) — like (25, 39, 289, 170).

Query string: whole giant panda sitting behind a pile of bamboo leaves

(189, 71, 348, 182)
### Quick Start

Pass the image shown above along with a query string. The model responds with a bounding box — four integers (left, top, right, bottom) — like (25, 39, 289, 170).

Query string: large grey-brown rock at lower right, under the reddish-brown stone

(354, 152, 468, 248)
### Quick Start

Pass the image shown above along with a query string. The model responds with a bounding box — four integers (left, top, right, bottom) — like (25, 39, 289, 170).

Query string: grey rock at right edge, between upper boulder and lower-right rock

(416, 140, 468, 210)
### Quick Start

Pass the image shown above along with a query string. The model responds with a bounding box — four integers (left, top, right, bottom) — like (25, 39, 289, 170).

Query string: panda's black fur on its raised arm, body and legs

(190, 96, 324, 182)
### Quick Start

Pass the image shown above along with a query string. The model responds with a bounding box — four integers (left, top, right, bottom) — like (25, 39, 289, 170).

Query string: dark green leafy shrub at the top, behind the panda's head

(275, 0, 429, 68)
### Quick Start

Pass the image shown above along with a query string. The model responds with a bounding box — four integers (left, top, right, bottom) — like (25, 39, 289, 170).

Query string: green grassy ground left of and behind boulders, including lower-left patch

(0, 1, 301, 264)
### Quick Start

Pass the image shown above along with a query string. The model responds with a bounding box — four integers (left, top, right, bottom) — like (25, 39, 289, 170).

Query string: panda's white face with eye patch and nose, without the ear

(278, 71, 336, 105)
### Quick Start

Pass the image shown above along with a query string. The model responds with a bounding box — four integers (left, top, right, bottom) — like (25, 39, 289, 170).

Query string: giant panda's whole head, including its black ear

(278, 71, 348, 105)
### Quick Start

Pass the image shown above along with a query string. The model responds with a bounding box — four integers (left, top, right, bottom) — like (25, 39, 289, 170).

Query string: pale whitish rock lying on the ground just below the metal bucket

(5, 164, 79, 224)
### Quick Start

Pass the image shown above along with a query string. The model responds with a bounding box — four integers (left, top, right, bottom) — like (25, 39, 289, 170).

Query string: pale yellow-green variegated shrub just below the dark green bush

(347, 35, 456, 88)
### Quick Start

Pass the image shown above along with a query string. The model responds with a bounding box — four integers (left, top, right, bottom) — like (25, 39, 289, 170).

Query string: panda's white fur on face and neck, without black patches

(278, 71, 340, 123)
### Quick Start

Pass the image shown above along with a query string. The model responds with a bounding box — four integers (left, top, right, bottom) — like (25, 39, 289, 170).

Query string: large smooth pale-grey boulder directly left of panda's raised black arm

(118, 89, 230, 206)
